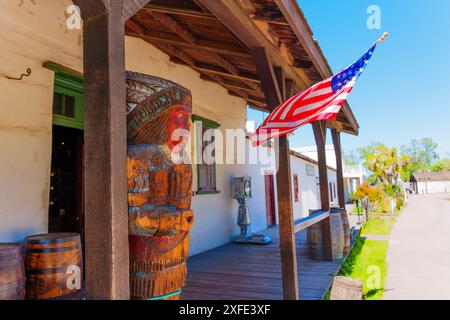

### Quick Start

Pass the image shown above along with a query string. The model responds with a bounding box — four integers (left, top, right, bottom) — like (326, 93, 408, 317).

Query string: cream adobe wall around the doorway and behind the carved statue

(0, 0, 246, 254)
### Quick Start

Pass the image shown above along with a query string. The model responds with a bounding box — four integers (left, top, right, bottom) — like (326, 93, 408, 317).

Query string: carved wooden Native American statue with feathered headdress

(127, 72, 194, 300)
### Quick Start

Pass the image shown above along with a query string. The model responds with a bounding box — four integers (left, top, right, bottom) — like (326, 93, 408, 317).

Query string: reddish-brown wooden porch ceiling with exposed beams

(125, 0, 358, 134)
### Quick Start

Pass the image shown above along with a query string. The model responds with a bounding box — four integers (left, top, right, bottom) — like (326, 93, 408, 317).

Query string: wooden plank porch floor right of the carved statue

(181, 228, 340, 300)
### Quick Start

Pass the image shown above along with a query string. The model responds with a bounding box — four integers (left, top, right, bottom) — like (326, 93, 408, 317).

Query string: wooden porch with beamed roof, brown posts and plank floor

(74, 0, 359, 300)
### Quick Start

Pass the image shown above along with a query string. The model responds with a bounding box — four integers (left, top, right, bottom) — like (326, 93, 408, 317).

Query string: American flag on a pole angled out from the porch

(252, 40, 380, 146)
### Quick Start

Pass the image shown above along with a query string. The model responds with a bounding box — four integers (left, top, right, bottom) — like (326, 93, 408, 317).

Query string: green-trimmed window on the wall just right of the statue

(192, 115, 220, 194)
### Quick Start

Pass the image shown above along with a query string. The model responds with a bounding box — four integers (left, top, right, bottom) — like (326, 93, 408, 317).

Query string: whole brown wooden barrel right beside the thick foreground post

(25, 233, 83, 300)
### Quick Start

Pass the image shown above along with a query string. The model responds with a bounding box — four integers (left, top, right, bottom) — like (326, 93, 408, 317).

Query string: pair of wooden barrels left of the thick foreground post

(0, 233, 83, 300)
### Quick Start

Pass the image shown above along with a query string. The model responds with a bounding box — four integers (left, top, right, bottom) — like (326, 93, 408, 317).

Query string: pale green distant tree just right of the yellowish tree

(400, 138, 439, 173)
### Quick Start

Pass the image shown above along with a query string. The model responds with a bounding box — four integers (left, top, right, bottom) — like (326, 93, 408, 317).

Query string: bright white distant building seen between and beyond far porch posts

(293, 145, 368, 202)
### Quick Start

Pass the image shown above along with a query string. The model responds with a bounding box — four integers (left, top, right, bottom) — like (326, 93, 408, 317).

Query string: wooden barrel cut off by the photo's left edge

(0, 243, 25, 300)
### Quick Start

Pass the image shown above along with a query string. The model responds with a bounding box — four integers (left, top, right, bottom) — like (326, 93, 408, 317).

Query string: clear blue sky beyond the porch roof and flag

(249, 0, 450, 157)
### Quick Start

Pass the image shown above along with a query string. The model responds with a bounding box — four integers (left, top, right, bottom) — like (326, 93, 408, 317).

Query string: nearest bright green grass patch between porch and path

(332, 237, 389, 300)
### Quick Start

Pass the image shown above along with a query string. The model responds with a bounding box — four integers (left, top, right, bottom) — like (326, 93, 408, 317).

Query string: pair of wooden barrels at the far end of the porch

(307, 208, 350, 262)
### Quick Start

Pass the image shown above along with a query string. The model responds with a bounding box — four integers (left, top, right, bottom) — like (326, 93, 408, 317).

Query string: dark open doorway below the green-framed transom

(49, 125, 84, 239)
